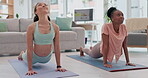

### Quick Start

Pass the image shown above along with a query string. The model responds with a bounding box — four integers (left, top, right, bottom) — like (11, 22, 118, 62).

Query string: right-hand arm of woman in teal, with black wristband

(53, 24, 66, 72)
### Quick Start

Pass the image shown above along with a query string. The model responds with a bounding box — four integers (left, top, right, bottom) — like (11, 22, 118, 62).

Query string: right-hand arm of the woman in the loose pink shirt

(122, 37, 135, 66)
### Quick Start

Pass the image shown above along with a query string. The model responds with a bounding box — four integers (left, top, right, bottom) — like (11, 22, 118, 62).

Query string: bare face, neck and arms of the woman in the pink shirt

(102, 10, 135, 68)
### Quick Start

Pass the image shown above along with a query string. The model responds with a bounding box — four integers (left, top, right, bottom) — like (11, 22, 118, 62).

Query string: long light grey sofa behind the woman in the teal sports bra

(0, 19, 85, 55)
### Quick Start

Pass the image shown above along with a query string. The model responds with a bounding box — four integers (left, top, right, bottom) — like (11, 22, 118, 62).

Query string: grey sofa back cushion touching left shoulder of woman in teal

(20, 18, 33, 32)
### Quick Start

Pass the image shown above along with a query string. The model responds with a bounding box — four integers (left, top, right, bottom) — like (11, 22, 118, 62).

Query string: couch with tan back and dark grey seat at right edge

(126, 18, 148, 48)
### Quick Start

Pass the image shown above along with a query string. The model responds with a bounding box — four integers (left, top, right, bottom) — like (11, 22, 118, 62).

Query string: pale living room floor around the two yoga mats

(0, 52, 148, 78)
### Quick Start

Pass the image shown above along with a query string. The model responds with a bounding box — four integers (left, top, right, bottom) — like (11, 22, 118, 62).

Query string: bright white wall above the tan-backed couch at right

(117, 0, 148, 19)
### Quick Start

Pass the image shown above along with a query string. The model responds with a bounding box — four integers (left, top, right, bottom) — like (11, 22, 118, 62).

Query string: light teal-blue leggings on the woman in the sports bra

(22, 50, 53, 64)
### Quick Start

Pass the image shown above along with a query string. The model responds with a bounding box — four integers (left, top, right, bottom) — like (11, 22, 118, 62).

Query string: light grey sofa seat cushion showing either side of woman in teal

(0, 31, 77, 44)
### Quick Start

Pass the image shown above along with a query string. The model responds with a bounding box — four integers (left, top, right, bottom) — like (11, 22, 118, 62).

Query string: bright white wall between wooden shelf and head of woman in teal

(14, 0, 50, 18)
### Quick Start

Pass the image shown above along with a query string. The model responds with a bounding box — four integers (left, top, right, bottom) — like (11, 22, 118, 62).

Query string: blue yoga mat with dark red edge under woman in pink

(67, 55, 148, 72)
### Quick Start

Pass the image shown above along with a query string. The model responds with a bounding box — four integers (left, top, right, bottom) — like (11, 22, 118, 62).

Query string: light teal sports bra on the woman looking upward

(34, 22, 55, 45)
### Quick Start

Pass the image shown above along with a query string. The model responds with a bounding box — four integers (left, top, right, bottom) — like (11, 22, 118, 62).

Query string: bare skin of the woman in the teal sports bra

(18, 3, 66, 75)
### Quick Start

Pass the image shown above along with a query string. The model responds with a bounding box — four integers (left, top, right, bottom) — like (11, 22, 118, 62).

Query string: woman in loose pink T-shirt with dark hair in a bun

(80, 7, 135, 68)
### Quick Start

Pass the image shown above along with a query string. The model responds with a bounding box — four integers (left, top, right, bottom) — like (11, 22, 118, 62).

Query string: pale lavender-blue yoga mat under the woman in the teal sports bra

(8, 59, 79, 78)
